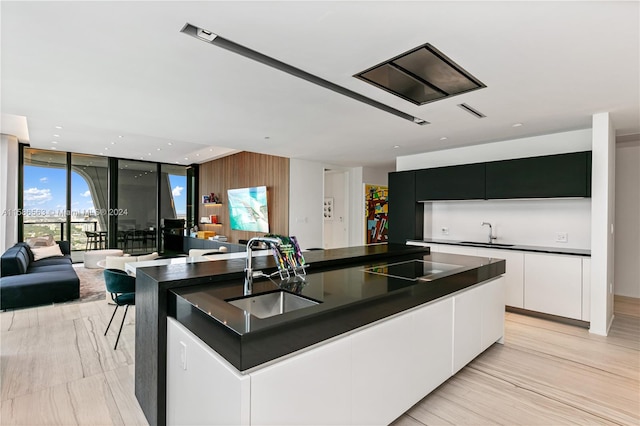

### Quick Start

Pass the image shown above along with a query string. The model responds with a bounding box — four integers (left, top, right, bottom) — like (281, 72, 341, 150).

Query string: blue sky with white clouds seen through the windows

(24, 166, 187, 216)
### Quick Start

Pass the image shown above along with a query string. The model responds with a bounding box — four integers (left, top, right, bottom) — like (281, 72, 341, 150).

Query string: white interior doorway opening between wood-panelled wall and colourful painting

(323, 169, 349, 249)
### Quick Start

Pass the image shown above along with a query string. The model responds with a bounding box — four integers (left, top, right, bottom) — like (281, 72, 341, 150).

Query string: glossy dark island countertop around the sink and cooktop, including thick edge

(169, 252, 505, 370)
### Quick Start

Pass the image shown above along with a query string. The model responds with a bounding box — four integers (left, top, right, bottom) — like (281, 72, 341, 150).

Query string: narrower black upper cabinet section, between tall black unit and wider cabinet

(416, 163, 485, 201)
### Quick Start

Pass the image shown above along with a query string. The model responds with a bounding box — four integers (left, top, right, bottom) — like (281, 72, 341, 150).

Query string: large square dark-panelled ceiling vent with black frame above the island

(354, 43, 487, 105)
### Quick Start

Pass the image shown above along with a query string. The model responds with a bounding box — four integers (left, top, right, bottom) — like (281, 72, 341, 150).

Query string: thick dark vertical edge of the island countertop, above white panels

(169, 255, 505, 371)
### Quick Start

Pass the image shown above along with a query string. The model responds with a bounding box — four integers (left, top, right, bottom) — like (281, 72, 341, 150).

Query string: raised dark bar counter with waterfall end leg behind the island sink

(135, 244, 436, 425)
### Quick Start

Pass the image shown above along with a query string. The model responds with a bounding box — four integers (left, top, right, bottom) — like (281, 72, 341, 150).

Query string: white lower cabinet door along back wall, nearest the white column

(524, 253, 582, 319)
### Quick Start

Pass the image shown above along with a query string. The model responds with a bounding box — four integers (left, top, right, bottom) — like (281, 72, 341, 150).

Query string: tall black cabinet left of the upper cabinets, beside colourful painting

(388, 170, 424, 244)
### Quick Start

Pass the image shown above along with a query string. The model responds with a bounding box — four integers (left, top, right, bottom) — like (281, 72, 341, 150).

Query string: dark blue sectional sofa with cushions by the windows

(0, 241, 80, 309)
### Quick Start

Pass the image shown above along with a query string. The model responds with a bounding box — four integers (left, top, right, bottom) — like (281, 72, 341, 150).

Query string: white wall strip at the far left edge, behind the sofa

(0, 134, 18, 254)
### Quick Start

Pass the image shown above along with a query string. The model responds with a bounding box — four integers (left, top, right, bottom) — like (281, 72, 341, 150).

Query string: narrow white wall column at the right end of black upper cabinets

(589, 113, 616, 336)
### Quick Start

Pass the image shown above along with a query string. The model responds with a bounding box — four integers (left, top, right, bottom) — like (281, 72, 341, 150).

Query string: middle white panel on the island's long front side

(351, 299, 453, 425)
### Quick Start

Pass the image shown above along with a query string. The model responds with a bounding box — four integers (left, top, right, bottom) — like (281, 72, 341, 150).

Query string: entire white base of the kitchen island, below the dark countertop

(167, 277, 504, 425)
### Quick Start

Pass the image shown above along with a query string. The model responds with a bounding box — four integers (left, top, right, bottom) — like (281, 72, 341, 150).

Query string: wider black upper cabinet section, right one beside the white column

(486, 151, 591, 199)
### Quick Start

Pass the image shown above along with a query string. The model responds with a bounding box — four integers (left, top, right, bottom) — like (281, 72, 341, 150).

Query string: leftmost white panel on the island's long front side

(251, 338, 350, 425)
